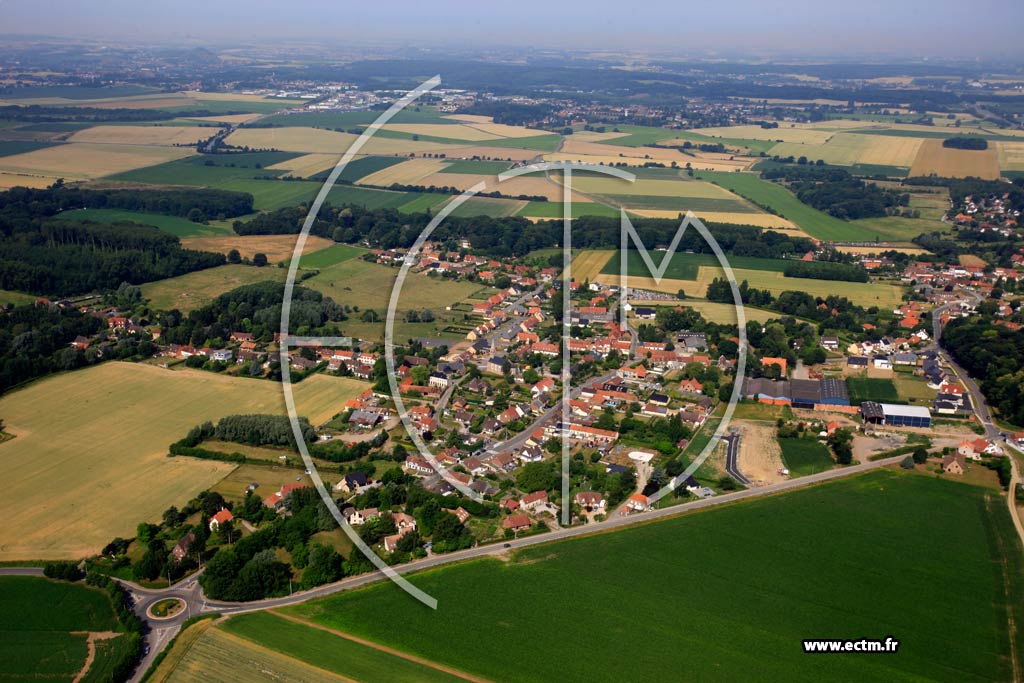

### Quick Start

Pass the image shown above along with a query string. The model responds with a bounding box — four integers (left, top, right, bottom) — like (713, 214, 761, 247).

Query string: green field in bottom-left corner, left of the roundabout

(0, 577, 124, 682)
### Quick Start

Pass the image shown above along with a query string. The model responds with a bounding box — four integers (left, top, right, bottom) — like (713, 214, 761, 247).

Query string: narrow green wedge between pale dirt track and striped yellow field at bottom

(220, 612, 465, 683)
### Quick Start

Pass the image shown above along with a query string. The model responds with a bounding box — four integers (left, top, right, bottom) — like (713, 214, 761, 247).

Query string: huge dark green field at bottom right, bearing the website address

(287, 470, 1024, 683)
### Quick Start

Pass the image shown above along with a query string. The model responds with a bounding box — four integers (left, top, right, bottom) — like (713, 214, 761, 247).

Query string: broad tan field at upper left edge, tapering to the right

(0, 142, 196, 180)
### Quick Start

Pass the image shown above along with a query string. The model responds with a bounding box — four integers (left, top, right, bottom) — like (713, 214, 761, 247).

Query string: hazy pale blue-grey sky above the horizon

(0, 0, 1024, 58)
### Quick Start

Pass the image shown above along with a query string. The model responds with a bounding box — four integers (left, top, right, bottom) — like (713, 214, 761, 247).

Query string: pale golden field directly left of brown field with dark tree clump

(771, 133, 924, 171)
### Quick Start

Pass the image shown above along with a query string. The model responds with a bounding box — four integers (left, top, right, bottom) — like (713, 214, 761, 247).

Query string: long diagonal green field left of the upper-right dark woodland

(698, 171, 874, 242)
